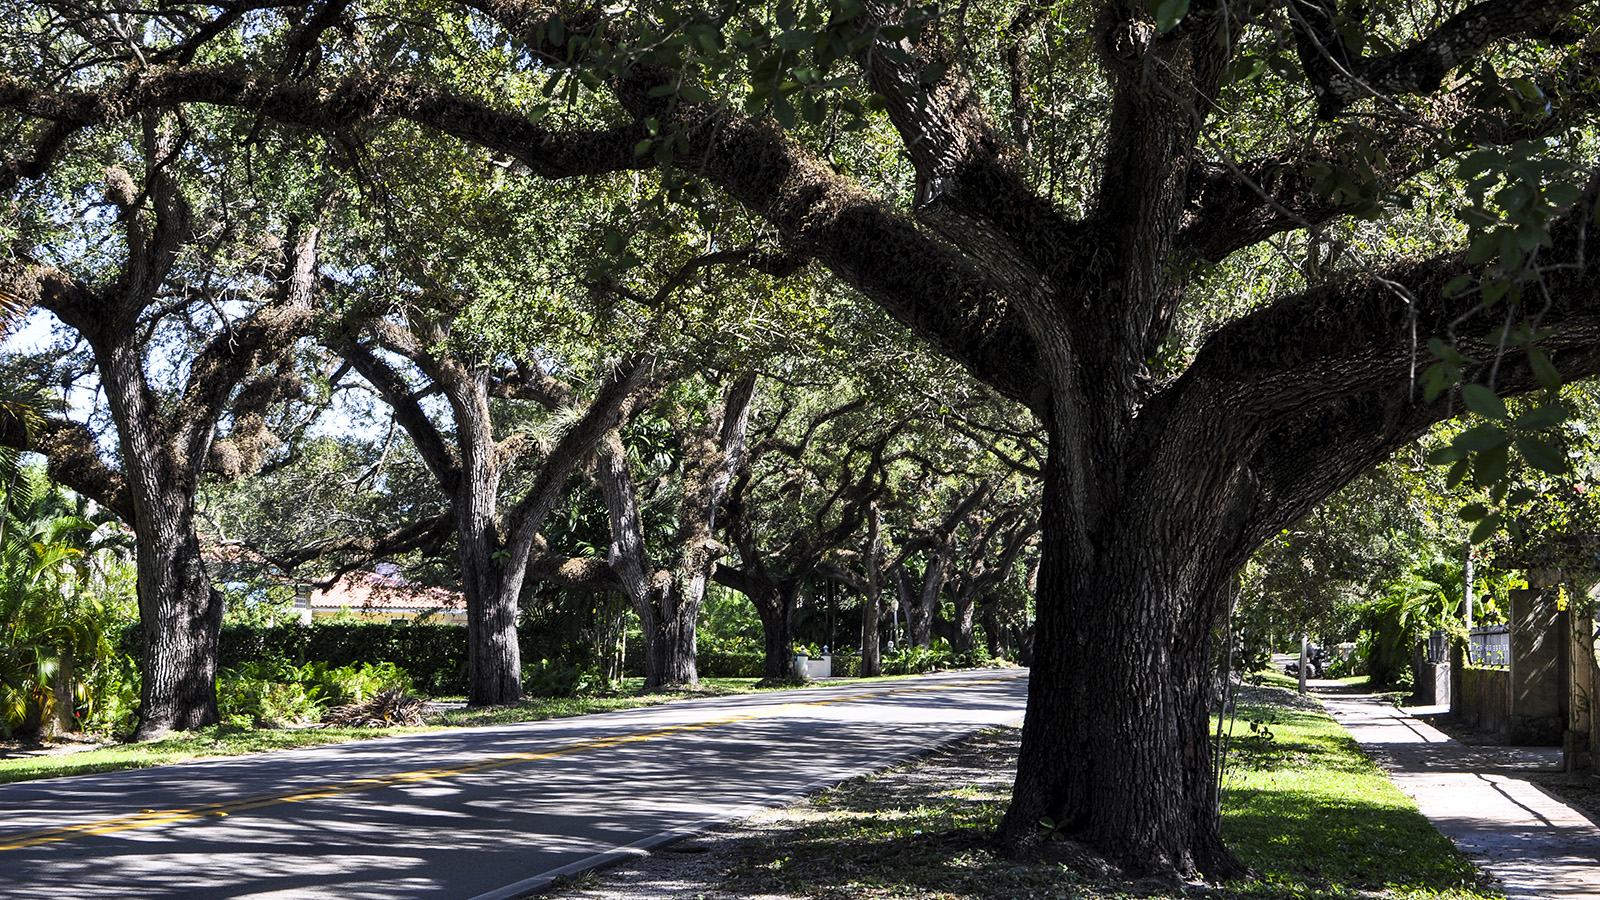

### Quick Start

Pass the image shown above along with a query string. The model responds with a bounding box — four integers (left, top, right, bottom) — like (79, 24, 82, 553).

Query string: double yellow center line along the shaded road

(0, 676, 1021, 850)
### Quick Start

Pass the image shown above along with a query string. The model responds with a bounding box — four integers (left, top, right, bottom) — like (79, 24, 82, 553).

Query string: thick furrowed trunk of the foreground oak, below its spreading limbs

(1002, 429, 1245, 878)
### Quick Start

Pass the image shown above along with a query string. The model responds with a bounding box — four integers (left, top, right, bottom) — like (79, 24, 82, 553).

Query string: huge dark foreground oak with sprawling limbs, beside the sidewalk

(9, 0, 1600, 876)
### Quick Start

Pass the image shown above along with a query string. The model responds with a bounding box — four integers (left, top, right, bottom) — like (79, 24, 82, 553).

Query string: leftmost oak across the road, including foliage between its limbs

(0, 112, 330, 738)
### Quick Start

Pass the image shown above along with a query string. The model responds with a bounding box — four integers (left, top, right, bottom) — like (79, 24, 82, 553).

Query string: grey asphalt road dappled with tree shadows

(0, 669, 1027, 900)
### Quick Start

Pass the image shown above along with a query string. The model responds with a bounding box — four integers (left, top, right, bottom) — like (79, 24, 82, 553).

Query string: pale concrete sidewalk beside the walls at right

(1318, 682, 1600, 900)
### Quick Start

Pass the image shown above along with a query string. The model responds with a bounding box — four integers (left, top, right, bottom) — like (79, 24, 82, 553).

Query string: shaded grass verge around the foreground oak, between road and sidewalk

(552, 687, 1499, 900)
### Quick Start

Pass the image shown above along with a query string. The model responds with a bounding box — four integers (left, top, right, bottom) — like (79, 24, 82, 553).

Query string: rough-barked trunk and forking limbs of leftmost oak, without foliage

(0, 128, 320, 740)
